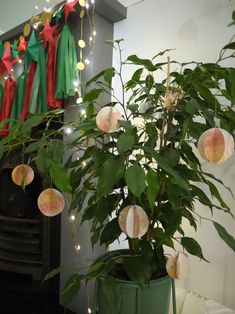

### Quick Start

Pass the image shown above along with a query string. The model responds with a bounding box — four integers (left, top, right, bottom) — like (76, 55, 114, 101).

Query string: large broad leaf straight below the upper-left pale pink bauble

(97, 155, 125, 197)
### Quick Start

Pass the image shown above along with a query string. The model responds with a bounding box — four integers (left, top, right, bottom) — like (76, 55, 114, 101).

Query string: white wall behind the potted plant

(111, 0, 235, 309)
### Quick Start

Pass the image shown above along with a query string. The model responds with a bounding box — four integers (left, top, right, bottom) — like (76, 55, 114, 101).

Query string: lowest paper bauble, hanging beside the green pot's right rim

(166, 252, 190, 279)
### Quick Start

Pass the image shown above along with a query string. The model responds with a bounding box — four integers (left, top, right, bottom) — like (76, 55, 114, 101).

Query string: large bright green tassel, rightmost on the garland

(55, 24, 79, 99)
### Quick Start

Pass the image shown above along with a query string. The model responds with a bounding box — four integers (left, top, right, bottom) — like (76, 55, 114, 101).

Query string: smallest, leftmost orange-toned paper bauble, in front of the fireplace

(11, 164, 34, 186)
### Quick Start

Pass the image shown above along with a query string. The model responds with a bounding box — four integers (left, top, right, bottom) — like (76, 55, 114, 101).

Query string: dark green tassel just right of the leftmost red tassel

(9, 72, 28, 129)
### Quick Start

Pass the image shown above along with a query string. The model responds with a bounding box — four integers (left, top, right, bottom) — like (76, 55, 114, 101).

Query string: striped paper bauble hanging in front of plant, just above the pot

(118, 205, 149, 238)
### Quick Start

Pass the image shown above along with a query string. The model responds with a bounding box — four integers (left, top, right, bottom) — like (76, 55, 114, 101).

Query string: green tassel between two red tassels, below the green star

(29, 49, 47, 113)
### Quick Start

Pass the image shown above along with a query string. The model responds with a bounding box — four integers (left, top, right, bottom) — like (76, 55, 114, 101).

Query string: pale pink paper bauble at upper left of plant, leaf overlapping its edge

(96, 106, 122, 133)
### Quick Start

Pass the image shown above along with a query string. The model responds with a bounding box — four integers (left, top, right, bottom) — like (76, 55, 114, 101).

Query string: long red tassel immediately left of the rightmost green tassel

(47, 36, 62, 109)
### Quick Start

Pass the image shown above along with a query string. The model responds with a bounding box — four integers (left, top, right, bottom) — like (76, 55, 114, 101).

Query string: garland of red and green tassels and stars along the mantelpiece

(0, 0, 96, 136)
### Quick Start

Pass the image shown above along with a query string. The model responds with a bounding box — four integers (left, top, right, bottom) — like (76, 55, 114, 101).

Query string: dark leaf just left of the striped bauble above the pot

(100, 218, 122, 246)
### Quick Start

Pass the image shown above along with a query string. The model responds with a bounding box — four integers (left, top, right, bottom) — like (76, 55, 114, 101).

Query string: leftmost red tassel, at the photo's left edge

(0, 77, 16, 136)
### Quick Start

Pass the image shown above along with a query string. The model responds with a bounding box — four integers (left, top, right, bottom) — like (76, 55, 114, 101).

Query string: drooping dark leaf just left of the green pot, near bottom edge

(61, 274, 83, 306)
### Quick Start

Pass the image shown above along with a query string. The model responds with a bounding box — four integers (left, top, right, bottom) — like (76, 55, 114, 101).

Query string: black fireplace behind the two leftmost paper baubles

(0, 158, 67, 314)
